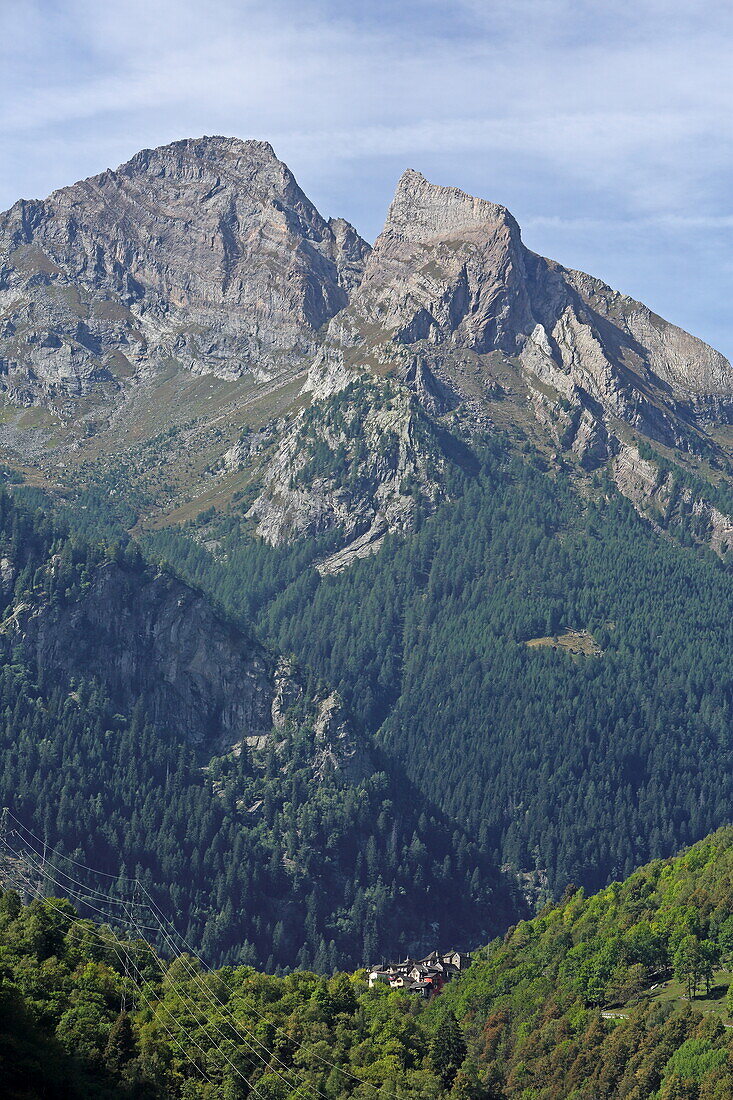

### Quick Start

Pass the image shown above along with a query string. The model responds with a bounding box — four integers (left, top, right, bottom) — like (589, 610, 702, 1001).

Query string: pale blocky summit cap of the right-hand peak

(384, 168, 518, 241)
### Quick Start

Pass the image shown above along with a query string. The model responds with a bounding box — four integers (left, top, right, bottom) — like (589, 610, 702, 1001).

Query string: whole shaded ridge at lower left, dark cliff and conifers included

(0, 494, 517, 971)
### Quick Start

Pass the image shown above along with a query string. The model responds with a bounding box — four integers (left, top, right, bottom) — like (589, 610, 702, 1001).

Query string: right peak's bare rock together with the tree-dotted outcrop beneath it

(239, 172, 733, 572)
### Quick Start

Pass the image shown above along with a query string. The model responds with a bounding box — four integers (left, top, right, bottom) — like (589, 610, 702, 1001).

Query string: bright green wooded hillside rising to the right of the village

(436, 828, 733, 1100)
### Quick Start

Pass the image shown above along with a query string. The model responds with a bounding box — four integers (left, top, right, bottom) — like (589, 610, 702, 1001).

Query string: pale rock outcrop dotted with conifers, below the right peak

(242, 374, 471, 573)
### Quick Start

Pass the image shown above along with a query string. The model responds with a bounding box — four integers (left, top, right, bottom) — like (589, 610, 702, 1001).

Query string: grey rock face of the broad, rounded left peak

(0, 138, 369, 404)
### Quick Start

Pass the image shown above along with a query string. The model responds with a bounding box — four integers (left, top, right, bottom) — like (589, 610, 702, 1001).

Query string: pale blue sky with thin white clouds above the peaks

(0, 0, 733, 356)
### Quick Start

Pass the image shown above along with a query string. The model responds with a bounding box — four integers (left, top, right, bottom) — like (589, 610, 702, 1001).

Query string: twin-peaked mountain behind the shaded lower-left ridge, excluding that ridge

(0, 139, 733, 960)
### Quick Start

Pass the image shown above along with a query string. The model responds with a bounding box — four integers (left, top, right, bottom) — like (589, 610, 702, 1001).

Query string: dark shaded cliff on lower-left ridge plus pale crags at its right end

(3, 561, 374, 782)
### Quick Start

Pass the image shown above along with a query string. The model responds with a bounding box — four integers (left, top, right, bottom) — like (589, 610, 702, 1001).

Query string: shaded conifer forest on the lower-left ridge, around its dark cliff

(0, 494, 515, 971)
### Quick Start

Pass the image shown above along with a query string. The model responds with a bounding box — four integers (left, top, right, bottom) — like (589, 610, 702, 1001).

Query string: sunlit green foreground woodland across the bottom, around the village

(0, 828, 733, 1100)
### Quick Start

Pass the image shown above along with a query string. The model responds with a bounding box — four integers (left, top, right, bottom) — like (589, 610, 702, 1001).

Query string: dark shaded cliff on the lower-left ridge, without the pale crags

(13, 563, 274, 749)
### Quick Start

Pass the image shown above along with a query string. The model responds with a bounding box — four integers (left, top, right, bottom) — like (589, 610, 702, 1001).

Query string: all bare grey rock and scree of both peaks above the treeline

(0, 138, 733, 571)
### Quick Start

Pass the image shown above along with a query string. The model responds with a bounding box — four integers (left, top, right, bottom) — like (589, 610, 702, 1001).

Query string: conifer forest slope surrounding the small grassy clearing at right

(145, 439, 733, 897)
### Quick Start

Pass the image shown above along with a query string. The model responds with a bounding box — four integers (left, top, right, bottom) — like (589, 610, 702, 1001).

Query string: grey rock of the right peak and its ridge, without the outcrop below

(313, 172, 733, 463)
